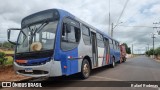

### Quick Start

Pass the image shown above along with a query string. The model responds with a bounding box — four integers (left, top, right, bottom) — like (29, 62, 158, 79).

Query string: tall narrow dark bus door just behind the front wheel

(91, 32, 98, 67)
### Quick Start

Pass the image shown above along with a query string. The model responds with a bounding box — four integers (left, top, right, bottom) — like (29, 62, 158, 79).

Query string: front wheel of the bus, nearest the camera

(81, 59, 91, 79)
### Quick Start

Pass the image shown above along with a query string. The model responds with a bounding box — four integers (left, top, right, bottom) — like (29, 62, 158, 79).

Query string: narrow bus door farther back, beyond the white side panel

(104, 38, 110, 64)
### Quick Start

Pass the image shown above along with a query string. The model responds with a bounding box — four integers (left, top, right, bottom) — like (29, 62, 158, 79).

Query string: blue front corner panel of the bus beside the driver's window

(54, 10, 78, 75)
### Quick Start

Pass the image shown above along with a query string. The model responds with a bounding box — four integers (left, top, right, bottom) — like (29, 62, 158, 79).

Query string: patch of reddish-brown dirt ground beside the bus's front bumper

(0, 65, 30, 81)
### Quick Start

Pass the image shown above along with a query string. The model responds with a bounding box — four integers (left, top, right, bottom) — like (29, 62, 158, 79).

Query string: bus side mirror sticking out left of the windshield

(7, 28, 21, 45)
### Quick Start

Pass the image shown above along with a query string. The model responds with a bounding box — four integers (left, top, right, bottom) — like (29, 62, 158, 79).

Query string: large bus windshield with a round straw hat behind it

(16, 20, 58, 53)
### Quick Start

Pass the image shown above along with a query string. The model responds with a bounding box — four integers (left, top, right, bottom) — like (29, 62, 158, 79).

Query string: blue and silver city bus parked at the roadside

(7, 9, 120, 79)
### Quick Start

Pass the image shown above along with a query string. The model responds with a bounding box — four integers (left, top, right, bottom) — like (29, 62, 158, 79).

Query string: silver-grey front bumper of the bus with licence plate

(14, 60, 62, 77)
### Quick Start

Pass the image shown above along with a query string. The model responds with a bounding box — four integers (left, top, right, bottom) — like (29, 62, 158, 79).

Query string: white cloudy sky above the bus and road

(0, 0, 160, 53)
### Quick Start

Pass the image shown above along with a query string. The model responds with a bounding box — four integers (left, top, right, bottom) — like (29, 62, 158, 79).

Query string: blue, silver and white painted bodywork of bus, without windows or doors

(11, 9, 120, 77)
